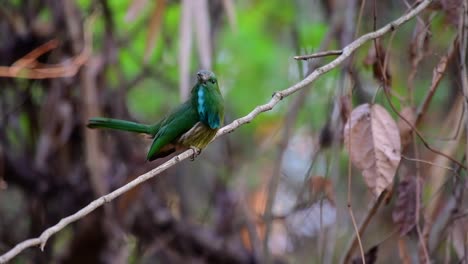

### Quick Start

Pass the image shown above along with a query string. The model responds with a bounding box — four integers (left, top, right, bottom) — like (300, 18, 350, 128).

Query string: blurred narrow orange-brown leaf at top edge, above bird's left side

(144, 0, 166, 63)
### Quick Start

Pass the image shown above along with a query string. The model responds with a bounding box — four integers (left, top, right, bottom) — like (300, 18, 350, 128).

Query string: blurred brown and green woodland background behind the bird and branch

(0, 0, 468, 263)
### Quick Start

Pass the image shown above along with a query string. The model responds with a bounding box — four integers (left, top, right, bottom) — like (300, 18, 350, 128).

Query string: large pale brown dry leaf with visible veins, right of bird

(344, 104, 401, 196)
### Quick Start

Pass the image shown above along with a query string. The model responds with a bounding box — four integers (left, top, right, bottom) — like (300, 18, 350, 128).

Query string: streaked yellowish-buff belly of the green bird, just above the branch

(177, 122, 218, 148)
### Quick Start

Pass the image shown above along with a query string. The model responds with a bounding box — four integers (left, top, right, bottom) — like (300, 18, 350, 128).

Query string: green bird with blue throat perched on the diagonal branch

(88, 70, 224, 161)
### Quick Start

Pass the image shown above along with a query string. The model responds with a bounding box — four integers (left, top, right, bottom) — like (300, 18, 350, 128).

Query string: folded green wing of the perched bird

(146, 101, 198, 161)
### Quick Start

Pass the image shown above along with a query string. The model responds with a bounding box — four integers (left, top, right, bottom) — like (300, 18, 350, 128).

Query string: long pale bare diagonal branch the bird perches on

(0, 0, 432, 263)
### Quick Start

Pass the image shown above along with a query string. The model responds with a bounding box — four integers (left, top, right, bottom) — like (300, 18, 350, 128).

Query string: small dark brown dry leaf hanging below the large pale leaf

(392, 177, 421, 236)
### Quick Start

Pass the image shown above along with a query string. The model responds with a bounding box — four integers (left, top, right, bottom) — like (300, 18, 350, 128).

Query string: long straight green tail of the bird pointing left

(87, 117, 155, 136)
